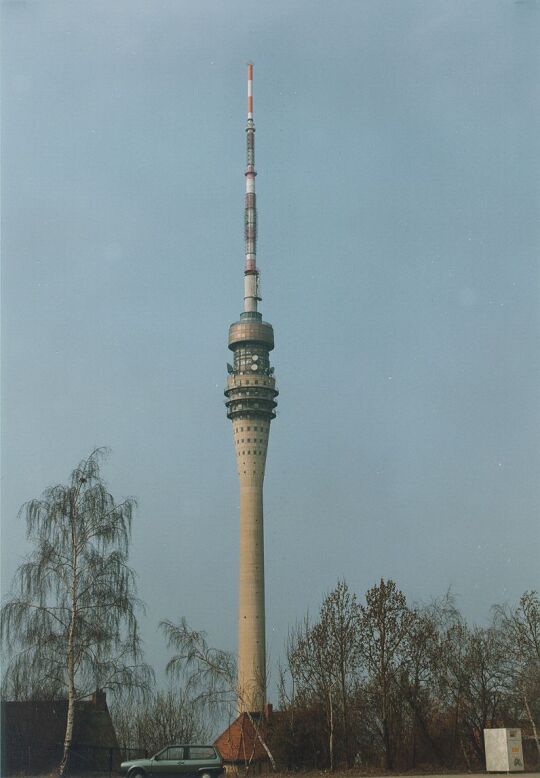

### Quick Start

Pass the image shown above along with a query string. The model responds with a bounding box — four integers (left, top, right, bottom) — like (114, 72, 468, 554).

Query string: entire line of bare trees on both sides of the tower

(0, 449, 540, 774)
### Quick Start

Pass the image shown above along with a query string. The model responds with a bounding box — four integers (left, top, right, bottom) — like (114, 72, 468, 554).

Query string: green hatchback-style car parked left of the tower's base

(120, 745, 224, 778)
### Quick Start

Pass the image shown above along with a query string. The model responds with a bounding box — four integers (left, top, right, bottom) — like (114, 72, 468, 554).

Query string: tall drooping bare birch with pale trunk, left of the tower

(0, 449, 151, 775)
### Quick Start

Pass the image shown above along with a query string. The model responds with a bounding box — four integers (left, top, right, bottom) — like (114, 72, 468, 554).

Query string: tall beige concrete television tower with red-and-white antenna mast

(225, 64, 278, 712)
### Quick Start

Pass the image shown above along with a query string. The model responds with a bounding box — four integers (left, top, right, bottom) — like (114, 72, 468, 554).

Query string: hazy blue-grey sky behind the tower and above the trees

(2, 0, 540, 692)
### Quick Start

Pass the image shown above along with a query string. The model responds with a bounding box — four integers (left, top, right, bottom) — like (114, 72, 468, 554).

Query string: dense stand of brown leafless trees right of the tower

(272, 580, 540, 770)
